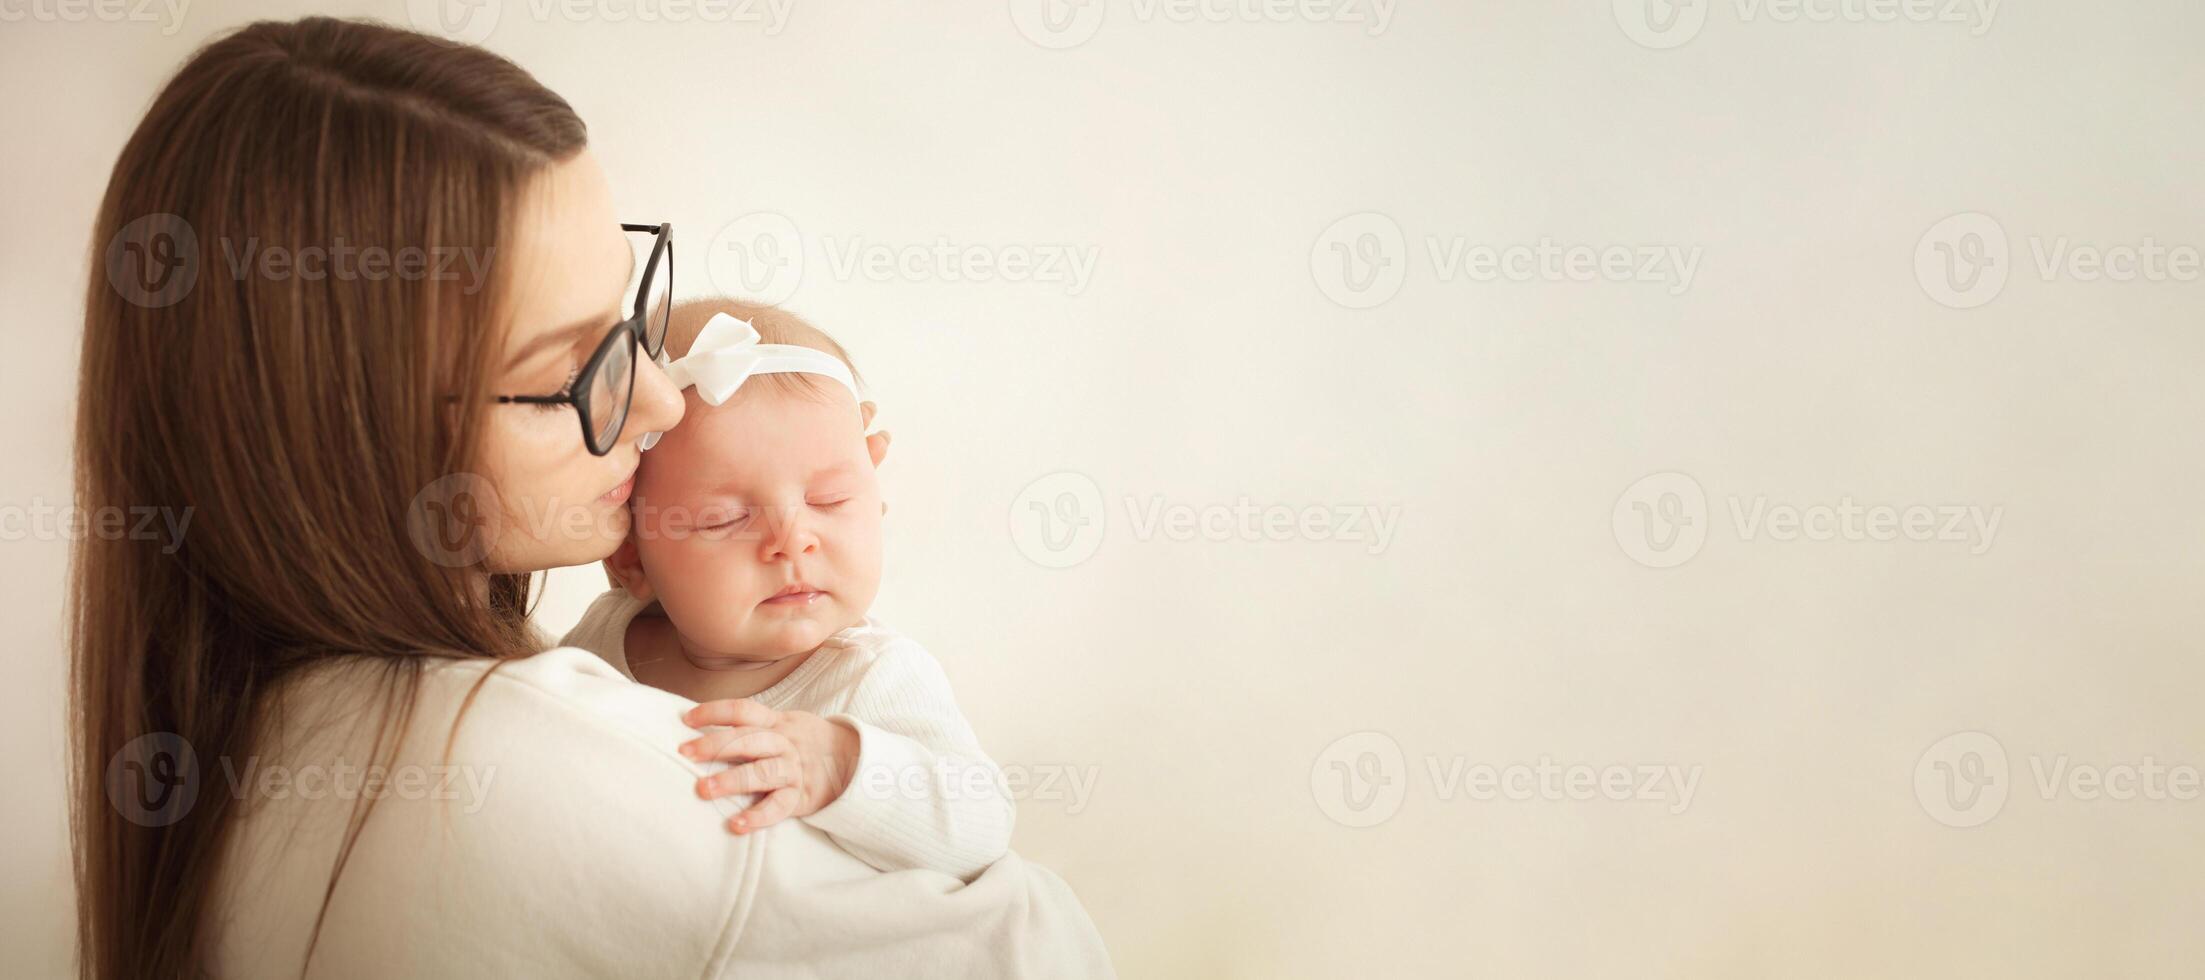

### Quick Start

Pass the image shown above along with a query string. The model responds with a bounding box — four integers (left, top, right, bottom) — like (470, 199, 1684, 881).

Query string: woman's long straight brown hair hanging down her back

(68, 18, 587, 978)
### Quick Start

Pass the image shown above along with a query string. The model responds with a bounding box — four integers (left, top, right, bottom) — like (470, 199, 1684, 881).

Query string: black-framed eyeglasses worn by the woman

(498, 223, 675, 457)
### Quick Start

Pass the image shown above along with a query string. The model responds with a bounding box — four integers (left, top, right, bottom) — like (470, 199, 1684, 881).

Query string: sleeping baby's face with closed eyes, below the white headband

(635, 380, 882, 660)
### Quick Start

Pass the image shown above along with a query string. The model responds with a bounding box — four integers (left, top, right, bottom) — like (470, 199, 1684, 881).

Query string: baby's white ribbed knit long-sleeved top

(560, 589, 1014, 881)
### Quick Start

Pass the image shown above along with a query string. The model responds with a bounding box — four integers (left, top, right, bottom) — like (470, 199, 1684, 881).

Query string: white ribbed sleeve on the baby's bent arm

(805, 636, 1017, 881)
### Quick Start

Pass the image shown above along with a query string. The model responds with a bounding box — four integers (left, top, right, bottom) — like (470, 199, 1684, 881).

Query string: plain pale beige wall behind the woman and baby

(0, 0, 2205, 978)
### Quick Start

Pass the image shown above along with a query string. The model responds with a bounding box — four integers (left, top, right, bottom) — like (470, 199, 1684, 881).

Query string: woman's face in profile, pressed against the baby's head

(483, 150, 681, 572)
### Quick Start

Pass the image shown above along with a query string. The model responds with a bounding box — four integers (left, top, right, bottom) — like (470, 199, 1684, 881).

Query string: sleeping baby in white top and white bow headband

(562, 300, 1012, 881)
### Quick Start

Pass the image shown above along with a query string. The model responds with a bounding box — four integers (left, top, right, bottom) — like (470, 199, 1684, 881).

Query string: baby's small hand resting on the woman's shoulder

(681, 697, 858, 834)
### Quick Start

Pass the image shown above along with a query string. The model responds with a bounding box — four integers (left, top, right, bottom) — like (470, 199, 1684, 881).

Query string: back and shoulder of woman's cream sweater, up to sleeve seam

(212, 647, 770, 976)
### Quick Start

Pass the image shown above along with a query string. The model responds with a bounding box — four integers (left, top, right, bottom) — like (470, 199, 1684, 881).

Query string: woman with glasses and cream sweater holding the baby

(71, 18, 1109, 978)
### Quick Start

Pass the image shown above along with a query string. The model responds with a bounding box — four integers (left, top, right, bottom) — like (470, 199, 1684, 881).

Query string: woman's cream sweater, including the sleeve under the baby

(196, 647, 1111, 980)
